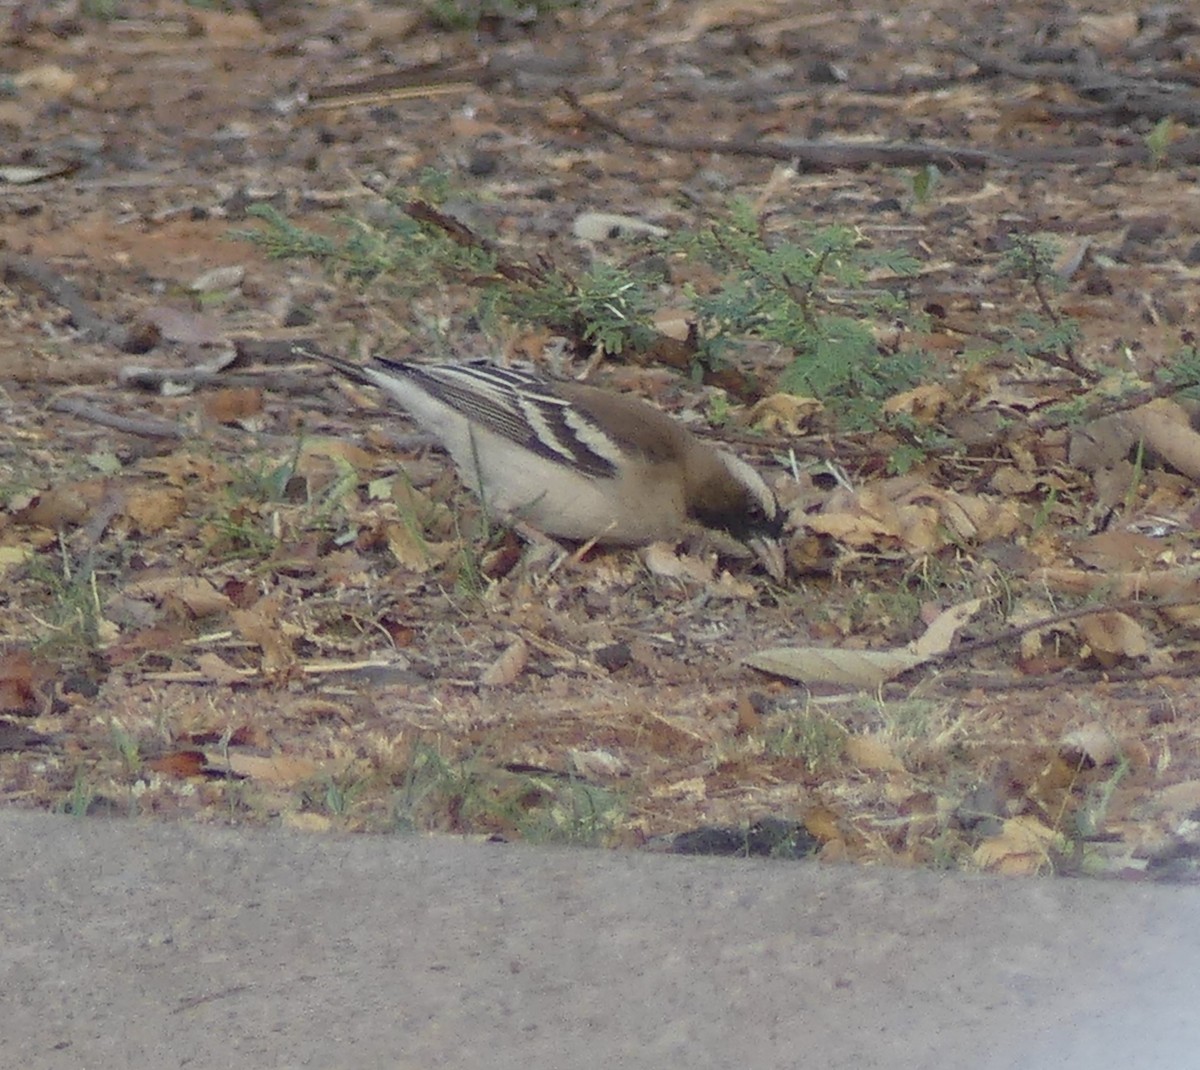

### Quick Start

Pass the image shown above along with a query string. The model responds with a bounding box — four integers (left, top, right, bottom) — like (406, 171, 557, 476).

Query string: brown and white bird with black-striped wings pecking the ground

(302, 349, 784, 547)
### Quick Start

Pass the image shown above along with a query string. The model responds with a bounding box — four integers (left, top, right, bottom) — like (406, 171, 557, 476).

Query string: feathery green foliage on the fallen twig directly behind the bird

(240, 188, 928, 427)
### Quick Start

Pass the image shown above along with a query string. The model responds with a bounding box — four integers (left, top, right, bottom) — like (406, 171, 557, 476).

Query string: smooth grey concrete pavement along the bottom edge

(0, 811, 1200, 1070)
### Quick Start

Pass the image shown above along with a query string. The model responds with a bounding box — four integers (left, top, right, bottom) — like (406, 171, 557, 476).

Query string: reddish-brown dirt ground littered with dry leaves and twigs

(0, 0, 1200, 879)
